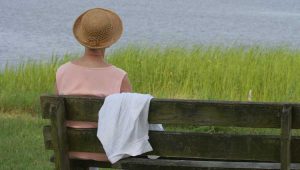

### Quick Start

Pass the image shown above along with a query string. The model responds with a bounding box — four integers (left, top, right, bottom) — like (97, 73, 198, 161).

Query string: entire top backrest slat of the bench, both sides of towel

(41, 96, 300, 128)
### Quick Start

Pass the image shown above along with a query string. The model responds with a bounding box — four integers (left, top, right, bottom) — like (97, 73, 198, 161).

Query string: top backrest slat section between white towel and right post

(149, 101, 282, 128)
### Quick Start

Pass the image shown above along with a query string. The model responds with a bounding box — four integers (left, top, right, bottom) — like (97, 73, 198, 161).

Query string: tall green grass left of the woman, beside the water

(0, 55, 71, 113)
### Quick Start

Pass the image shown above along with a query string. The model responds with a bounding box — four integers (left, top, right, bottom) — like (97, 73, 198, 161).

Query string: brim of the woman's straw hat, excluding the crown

(73, 8, 123, 49)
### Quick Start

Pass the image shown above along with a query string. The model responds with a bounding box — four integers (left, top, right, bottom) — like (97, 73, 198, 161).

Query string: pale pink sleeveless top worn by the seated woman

(56, 62, 127, 161)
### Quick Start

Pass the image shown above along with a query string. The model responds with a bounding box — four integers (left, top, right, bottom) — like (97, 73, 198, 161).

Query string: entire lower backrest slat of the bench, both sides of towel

(42, 128, 300, 163)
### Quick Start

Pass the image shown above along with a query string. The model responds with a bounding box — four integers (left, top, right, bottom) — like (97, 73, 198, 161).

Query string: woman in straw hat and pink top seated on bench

(56, 8, 131, 167)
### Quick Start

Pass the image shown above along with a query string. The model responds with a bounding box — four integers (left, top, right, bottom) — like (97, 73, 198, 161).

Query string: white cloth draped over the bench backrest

(97, 93, 163, 163)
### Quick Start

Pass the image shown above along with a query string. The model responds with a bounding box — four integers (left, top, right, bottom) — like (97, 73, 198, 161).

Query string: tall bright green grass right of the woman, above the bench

(111, 44, 300, 101)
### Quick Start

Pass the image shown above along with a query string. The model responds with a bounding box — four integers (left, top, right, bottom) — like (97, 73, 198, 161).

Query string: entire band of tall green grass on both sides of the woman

(0, 45, 300, 112)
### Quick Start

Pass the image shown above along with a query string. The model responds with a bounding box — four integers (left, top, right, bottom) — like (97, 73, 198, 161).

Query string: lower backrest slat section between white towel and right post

(150, 132, 279, 162)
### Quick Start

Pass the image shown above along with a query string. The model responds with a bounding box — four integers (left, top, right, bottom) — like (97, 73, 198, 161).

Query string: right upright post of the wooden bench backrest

(281, 106, 292, 170)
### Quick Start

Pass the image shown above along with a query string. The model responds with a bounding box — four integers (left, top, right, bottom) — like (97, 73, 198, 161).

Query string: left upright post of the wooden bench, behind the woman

(49, 98, 70, 170)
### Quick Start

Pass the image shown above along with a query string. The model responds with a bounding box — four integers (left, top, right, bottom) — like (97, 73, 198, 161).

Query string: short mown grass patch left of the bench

(0, 112, 53, 170)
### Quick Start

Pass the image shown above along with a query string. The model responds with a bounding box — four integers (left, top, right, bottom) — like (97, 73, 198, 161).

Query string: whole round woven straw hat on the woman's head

(73, 8, 123, 49)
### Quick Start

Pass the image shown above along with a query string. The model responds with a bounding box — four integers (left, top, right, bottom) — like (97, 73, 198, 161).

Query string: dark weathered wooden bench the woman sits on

(41, 95, 300, 170)
